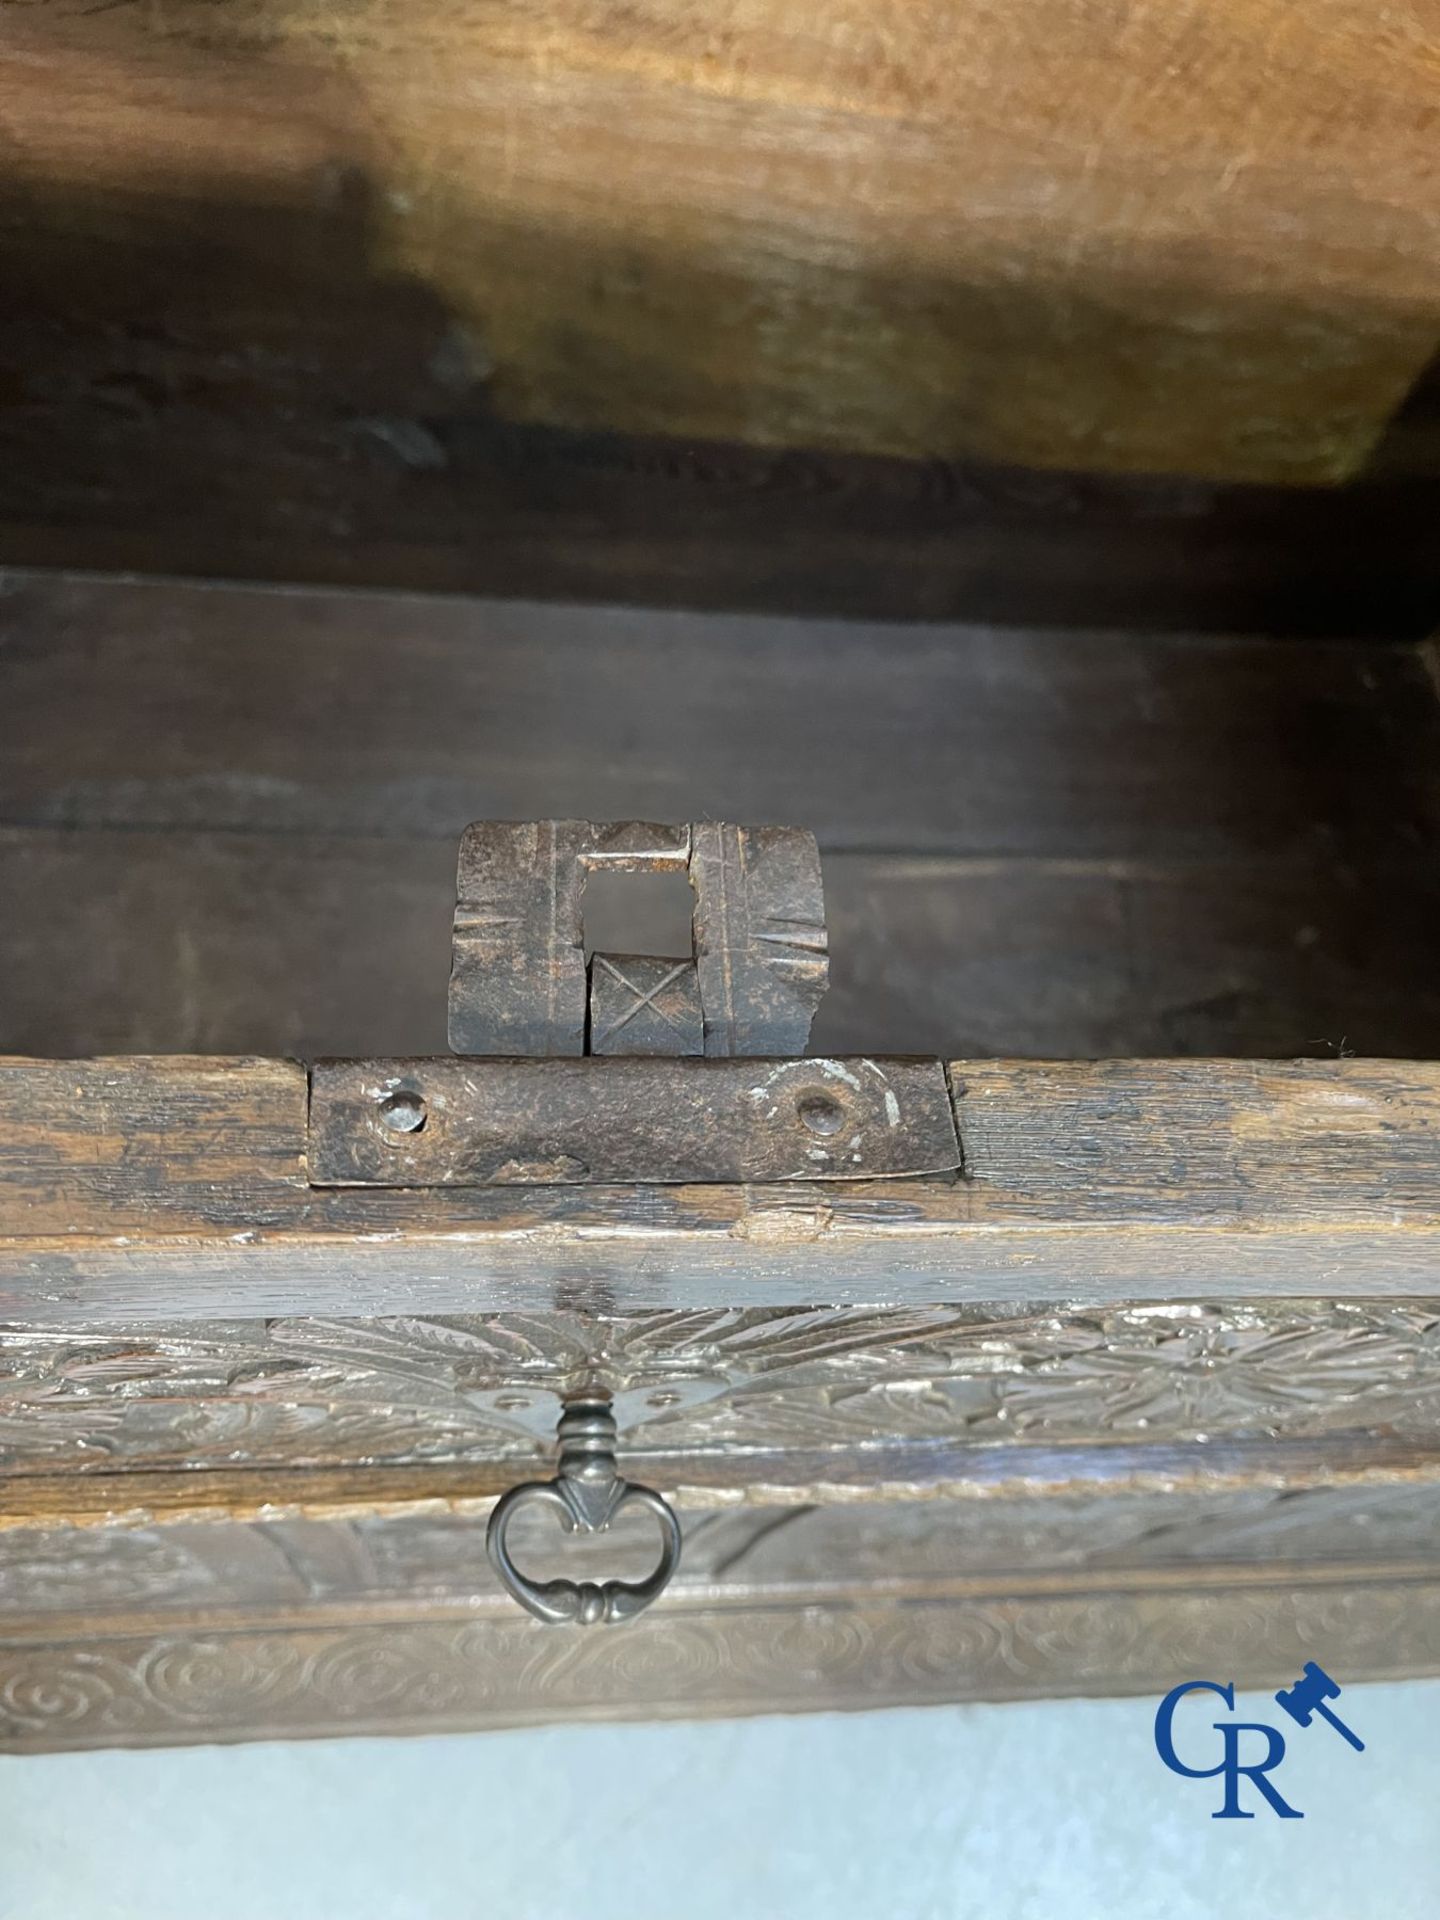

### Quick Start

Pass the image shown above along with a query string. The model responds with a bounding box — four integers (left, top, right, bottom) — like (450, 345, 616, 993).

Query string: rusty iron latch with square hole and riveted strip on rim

(309, 820, 960, 1187)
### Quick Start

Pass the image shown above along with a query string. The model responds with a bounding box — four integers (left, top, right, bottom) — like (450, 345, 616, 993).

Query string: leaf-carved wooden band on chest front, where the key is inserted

(0, 1300, 1440, 1471)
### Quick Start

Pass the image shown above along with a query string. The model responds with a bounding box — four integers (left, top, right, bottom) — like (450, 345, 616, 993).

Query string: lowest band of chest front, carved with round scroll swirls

(0, 1578, 1440, 1753)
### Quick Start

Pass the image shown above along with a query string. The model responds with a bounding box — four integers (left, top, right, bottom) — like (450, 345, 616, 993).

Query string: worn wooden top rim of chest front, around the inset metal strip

(0, 1058, 1440, 1325)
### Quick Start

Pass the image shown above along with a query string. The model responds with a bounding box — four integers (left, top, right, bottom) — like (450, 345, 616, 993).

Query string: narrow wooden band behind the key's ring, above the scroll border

(14, 1478, 1440, 1605)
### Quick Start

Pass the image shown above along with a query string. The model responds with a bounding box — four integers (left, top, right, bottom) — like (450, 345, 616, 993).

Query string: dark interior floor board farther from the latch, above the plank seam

(0, 574, 1440, 860)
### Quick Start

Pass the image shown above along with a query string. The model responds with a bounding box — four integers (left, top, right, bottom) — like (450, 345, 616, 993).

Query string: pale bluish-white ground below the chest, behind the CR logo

(0, 1680, 1440, 1920)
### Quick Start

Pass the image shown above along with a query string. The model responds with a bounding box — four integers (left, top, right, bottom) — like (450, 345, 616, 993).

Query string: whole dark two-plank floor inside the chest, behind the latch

(0, 576, 1440, 1058)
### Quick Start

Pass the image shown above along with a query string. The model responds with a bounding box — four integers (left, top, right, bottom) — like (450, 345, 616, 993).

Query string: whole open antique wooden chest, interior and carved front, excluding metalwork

(0, 0, 1440, 1749)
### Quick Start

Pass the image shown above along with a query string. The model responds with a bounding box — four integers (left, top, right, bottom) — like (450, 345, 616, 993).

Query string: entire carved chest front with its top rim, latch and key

(0, 822, 1440, 1749)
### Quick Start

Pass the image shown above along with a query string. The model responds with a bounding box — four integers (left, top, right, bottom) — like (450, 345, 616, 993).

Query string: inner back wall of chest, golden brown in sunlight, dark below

(0, 0, 1440, 606)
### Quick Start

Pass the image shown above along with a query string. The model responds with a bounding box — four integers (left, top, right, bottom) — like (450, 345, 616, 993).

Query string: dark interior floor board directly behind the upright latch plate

(11, 833, 1440, 1058)
